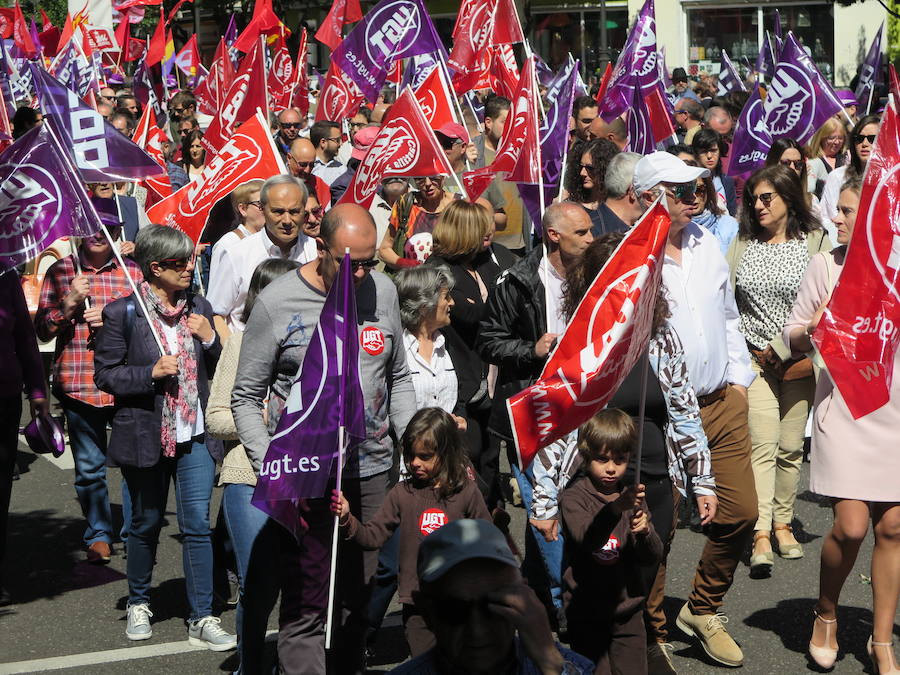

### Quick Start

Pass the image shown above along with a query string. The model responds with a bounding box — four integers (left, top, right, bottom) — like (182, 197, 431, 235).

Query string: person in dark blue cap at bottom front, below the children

(391, 519, 594, 675)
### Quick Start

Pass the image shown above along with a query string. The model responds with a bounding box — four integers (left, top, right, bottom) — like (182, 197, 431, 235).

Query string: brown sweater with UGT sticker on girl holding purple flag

(344, 480, 491, 604)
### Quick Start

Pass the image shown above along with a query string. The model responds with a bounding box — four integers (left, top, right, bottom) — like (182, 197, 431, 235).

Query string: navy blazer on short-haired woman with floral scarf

(94, 295, 223, 468)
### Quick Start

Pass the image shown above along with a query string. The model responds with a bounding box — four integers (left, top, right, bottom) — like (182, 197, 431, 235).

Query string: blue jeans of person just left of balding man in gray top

(222, 483, 281, 674)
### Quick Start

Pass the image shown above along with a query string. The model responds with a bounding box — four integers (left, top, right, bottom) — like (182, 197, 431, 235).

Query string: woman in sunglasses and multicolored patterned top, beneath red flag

(378, 176, 455, 270)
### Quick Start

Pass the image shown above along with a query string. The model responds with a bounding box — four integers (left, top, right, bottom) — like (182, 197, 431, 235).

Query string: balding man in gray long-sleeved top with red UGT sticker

(231, 204, 416, 673)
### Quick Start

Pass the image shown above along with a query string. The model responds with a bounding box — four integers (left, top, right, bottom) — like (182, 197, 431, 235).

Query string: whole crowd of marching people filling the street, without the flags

(0, 54, 900, 674)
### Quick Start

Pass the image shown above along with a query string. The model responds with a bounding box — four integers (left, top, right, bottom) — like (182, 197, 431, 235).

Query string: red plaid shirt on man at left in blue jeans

(34, 250, 143, 408)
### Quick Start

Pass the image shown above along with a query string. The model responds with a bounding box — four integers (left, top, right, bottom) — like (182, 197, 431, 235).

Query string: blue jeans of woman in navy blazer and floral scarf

(122, 436, 216, 621)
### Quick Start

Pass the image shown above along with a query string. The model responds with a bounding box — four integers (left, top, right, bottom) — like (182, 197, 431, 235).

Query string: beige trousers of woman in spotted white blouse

(747, 361, 816, 530)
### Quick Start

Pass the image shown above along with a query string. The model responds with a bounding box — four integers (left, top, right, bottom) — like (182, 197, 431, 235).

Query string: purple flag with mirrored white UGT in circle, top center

(331, 0, 444, 101)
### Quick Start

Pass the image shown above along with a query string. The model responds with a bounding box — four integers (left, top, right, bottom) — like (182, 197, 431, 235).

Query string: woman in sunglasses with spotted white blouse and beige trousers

(726, 164, 831, 578)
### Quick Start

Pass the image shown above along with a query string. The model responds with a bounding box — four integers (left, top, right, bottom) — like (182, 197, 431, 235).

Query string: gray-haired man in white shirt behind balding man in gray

(206, 175, 317, 340)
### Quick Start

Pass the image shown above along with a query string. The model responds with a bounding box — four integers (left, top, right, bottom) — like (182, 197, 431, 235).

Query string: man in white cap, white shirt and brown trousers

(634, 152, 757, 666)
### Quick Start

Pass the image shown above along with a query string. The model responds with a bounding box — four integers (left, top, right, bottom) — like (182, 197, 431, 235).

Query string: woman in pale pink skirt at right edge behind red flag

(782, 179, 900, 675)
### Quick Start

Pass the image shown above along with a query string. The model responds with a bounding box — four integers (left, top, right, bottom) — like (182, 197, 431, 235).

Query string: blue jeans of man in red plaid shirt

(60, 396, 115, 546)
